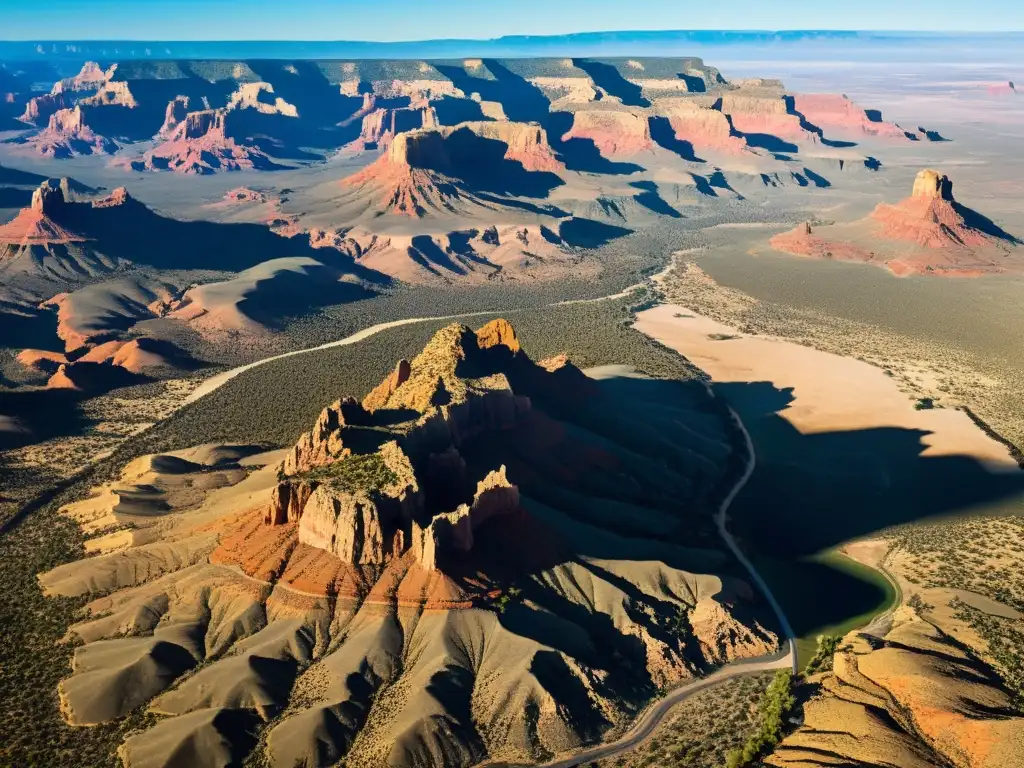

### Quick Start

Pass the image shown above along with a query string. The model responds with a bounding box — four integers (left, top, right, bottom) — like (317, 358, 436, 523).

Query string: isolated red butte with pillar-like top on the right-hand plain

(770, 170, 1020, 276)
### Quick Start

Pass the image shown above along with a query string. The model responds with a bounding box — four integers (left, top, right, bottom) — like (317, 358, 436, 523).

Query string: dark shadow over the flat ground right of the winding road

(713, 382, 1024, 635)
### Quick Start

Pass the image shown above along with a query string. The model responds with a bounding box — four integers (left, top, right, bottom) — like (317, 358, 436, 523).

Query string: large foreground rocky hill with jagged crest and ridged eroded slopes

(40, 319, 776, 766)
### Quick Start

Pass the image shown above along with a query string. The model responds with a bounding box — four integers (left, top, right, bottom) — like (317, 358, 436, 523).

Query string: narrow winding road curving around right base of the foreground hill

(477, 399, 797, 768)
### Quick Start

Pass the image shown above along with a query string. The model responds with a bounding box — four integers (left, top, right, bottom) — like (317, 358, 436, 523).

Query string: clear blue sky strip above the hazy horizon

(0, 0, 1024, 41)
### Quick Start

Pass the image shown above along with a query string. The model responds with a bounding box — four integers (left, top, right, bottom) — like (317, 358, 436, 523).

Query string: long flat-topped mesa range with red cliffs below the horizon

(2, 58, 936, 174)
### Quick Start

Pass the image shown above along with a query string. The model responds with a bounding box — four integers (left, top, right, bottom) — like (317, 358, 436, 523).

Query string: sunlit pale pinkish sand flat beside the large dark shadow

(636, 304, 1019, 471)
